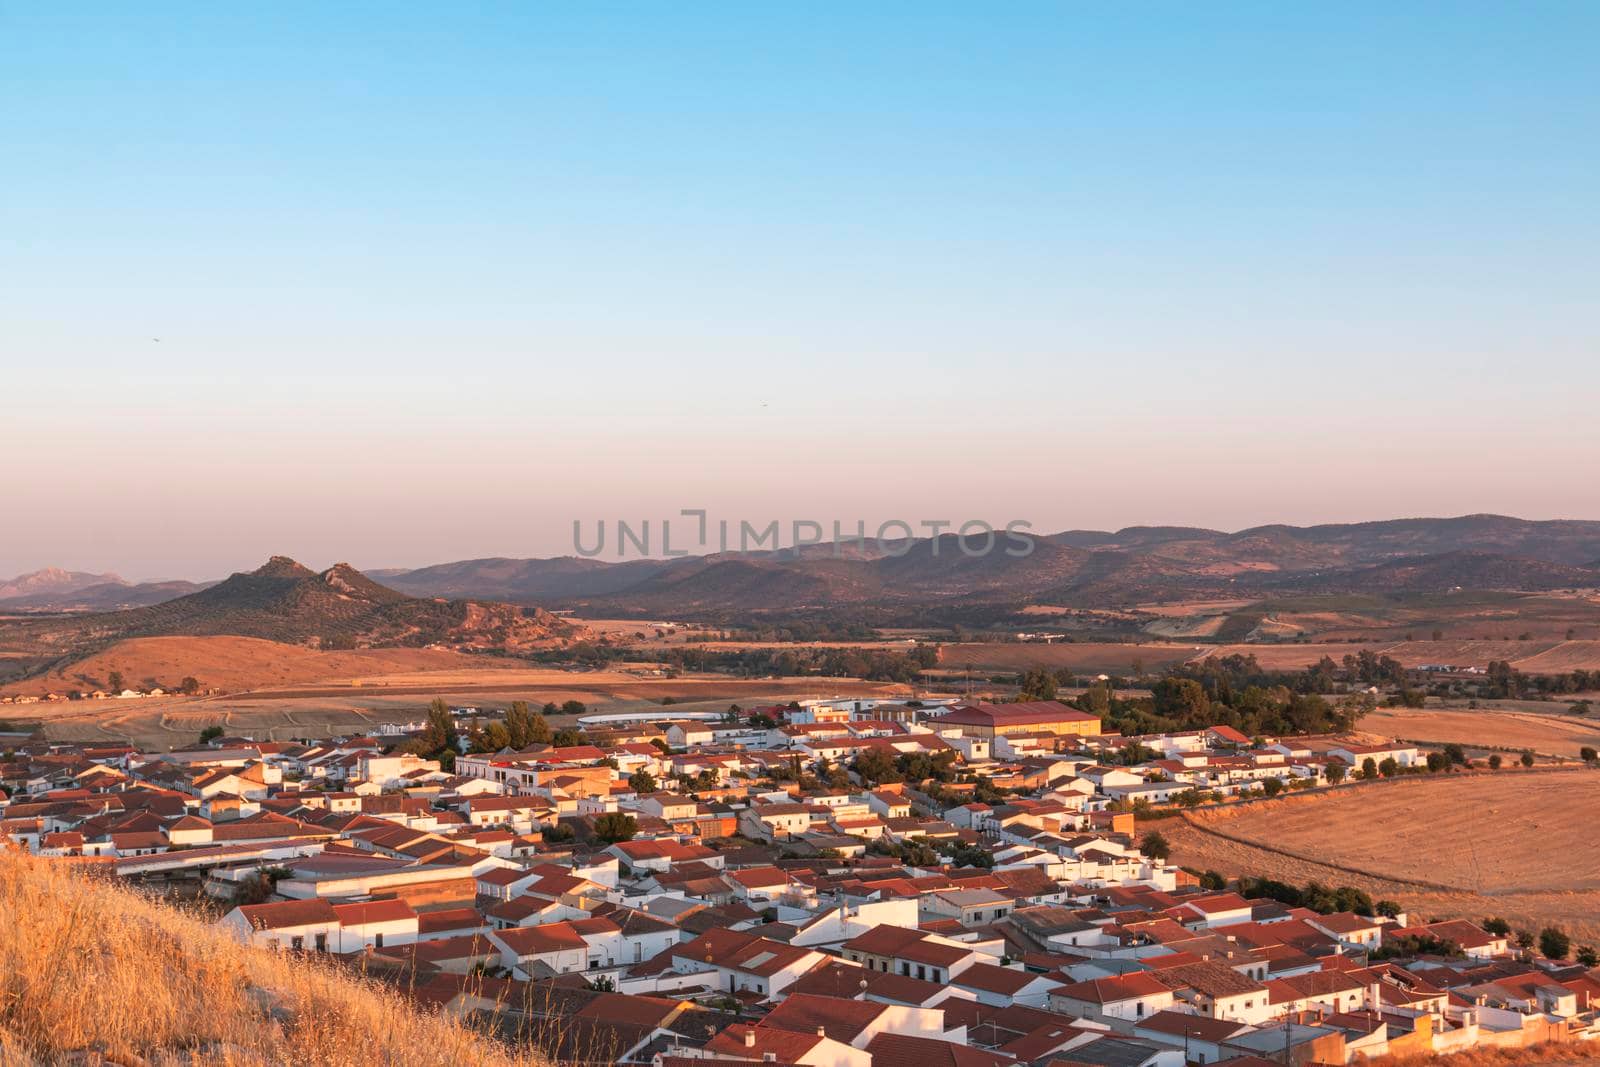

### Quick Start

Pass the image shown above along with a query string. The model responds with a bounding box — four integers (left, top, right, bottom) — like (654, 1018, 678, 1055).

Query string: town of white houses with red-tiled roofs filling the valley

(0, 697, 1600, 1067)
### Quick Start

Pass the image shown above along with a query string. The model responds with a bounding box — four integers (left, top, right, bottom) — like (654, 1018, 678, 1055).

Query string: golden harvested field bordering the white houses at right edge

(1160, 768, 1600, 942)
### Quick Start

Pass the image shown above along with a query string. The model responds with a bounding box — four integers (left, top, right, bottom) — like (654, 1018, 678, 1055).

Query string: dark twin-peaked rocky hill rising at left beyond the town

(0, 557, 573, 675)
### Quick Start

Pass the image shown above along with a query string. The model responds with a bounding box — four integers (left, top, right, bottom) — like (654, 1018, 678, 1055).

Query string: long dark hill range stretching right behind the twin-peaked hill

(368, 515, 1600, 617)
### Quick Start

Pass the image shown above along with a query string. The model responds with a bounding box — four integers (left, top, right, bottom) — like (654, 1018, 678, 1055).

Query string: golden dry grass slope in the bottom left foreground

(0, 849, 539, 1067)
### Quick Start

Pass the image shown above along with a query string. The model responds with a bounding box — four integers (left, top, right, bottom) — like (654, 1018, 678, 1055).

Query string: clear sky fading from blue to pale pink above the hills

(0, 0, 1600, 577)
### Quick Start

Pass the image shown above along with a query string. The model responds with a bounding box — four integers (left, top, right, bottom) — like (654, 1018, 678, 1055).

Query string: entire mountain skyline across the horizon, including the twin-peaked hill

(0, 515, 1600, 627)
